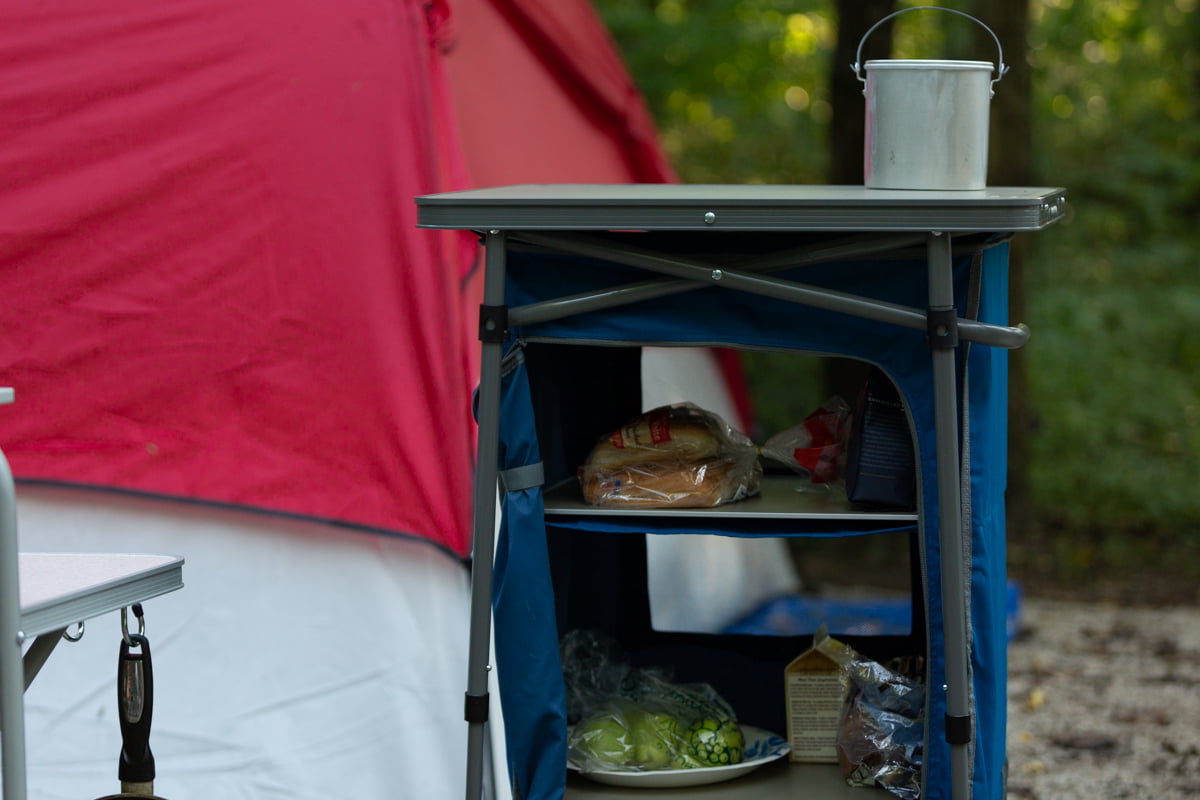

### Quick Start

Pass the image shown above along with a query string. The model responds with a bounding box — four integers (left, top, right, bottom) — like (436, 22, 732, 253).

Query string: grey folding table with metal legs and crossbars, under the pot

(416, 185, 1066, 800)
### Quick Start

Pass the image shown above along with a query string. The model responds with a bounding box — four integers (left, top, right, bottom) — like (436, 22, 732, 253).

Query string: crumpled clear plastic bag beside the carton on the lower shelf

(814, 630, 925, 800)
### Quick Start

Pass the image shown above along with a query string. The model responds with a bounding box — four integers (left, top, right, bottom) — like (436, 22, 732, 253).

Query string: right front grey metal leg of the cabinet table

(928, 233, 973, 800)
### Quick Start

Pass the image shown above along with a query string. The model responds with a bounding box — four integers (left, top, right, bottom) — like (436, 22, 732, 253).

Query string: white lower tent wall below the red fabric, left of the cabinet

(17, 486, 480, 800)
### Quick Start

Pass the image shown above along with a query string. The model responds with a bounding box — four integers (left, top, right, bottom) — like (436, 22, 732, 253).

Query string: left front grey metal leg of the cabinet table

(466, 231, 505, 800)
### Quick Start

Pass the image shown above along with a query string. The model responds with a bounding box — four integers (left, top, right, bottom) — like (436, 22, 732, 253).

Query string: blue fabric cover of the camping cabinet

(494, 241, 1008, 800)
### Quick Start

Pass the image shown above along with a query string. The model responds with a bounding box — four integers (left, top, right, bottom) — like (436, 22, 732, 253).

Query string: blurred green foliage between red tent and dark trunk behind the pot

(596, 0, 834, 184)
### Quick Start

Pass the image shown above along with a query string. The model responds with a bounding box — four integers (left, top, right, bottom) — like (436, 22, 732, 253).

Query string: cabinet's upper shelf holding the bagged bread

(545, 475, 917, 523)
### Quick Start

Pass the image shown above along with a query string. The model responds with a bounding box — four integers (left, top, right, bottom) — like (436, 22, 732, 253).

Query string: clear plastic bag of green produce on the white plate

(562, 631, 745, 772)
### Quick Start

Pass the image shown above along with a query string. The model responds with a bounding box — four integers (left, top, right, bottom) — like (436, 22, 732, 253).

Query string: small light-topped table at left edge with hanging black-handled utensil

(0, 389, 184, 800)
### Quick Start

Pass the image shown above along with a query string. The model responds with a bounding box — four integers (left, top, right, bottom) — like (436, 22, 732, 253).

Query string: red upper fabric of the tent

(0, 0, 672, 555)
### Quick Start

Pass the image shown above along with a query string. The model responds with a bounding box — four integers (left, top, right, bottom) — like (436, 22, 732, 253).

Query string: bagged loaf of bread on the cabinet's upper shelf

(578, 403, 762, 509)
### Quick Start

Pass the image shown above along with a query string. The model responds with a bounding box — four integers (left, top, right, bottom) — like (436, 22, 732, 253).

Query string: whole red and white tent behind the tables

(0, 7, 777, 800)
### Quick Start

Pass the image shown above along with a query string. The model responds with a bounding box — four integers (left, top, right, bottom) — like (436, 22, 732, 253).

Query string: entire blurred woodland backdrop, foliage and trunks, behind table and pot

(595, 0, 1200, 600)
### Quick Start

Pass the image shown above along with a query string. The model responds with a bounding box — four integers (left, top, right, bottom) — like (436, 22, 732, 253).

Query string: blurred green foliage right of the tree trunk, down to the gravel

(1014, 0, 1200, 542)
